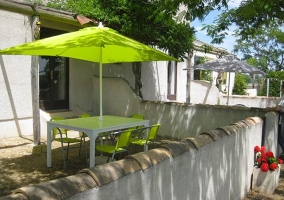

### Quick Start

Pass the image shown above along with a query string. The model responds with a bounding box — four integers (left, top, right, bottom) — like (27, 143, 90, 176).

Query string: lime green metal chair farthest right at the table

(129, 124, 161, 151)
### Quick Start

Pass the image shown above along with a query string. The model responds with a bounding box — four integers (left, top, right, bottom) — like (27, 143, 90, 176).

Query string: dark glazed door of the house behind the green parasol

(39, 28, 69, 110)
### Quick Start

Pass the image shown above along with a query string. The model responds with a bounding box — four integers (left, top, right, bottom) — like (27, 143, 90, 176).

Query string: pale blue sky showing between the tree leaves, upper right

(190, 0, 241, 58)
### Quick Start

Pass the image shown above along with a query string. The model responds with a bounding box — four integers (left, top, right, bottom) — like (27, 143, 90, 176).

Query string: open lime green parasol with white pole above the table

(0, 26, 178, 120)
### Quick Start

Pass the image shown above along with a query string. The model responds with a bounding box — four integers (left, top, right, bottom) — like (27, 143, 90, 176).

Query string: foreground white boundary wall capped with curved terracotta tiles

(0, 113, 278, 200)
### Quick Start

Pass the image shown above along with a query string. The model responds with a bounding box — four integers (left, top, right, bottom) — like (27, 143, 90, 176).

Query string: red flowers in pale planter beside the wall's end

(251, 146, 282, 194)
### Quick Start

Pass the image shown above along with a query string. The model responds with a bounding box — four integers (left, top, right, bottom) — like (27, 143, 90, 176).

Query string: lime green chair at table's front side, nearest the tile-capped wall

(96, 129, 132, 163)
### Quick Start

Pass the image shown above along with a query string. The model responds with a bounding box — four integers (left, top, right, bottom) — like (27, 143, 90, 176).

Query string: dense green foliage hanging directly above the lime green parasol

(44, 0, 195, 59)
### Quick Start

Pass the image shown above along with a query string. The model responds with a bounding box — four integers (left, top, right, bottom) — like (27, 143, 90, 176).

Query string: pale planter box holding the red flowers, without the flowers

(251, 166, 280, 194)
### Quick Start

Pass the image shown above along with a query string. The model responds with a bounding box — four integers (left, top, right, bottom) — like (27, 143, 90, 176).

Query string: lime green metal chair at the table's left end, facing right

(50, 117, 87, 169)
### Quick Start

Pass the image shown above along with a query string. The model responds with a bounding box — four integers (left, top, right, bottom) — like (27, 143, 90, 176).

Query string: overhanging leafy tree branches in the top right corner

(203, 0, 284, 44)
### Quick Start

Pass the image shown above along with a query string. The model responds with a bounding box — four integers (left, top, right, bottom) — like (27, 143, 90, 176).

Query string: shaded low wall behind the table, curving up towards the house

(92, 77, 266, 139)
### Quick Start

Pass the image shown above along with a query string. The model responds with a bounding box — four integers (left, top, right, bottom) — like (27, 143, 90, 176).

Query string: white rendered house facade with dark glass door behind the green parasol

(0, 0, 232, 138)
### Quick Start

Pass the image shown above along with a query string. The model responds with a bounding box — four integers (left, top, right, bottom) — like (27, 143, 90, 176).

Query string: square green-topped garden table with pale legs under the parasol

(47, 115, 150, 167)
